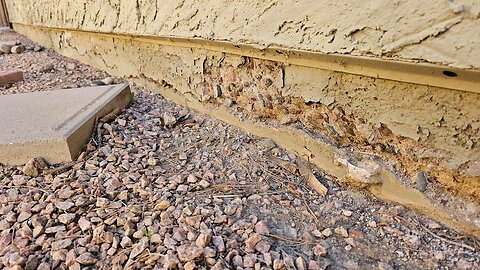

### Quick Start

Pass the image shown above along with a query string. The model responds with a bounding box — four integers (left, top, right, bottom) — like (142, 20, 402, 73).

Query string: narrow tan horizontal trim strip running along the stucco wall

(14, 23, 480, 94)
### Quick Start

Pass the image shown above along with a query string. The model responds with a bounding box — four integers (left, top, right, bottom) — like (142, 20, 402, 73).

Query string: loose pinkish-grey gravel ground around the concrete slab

(0, 32, 480, 270)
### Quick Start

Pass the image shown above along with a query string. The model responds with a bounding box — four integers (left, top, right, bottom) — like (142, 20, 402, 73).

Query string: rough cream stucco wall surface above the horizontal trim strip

(3, 0, 480, 69)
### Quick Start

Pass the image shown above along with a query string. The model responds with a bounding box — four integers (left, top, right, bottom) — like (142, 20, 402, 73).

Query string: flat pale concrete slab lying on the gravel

(0, 84, 130, 165)
